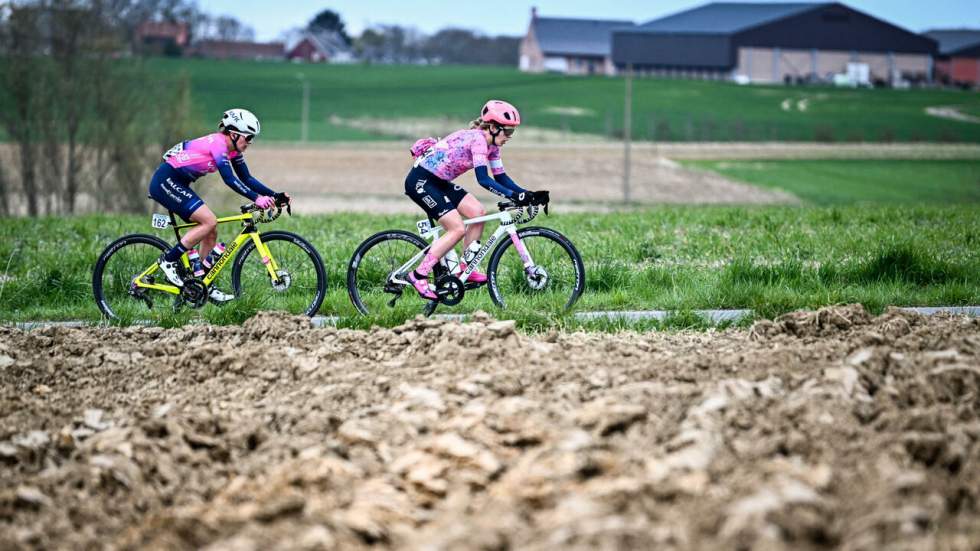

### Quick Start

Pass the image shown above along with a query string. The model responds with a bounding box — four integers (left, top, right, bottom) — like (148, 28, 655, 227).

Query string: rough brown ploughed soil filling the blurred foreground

(0, 307, 980, 550)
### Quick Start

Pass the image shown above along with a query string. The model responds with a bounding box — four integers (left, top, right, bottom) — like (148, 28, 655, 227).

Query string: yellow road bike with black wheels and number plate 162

(92, 203, 327, 322)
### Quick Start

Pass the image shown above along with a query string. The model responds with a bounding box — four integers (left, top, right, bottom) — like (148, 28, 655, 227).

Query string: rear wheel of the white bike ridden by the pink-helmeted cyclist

(347, 230, 427, 314)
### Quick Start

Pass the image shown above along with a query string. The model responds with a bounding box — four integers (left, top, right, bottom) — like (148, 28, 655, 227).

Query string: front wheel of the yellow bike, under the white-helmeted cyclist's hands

(231, 231, 327, 317)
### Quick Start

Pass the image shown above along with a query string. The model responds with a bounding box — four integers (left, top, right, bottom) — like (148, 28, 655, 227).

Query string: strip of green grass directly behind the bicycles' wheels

(0, 206, 980, 329)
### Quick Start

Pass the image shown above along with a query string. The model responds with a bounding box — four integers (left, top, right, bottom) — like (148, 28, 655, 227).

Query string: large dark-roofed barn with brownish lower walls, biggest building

(612, 2, 937, 84)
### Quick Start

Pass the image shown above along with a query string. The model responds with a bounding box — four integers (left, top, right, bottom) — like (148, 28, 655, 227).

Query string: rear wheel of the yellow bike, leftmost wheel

(92, 233, 173, 323)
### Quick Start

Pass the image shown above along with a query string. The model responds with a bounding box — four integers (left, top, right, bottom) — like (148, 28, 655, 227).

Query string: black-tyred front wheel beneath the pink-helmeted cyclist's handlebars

(487, 226, 585, 310)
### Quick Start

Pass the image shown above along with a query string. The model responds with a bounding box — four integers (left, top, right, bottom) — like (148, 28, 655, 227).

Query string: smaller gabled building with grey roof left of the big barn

(519, 8, 633, 75)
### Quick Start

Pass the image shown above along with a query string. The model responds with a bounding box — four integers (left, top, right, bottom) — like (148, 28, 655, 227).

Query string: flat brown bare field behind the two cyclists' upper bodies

(0, 140, 980, 214)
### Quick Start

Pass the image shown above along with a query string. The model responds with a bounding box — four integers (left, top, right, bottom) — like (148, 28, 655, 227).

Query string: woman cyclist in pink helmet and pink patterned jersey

(405, 100, 549, 300)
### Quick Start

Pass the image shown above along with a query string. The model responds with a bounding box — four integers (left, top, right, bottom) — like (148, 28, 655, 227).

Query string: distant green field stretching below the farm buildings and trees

(147, 58, 980, 142)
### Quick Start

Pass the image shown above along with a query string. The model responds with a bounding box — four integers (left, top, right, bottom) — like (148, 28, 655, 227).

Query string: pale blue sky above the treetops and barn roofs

(199, 0, 980, 41)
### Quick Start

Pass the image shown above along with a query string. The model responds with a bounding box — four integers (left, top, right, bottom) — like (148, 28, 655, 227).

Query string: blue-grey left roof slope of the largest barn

(636, 2, 826, 34)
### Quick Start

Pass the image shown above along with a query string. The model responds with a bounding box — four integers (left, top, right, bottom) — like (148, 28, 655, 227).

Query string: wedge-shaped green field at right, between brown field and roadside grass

(685, 160, 980, 205)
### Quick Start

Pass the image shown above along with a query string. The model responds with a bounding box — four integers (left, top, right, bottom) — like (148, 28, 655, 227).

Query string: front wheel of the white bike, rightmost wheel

(487, 227, 585, 311)
